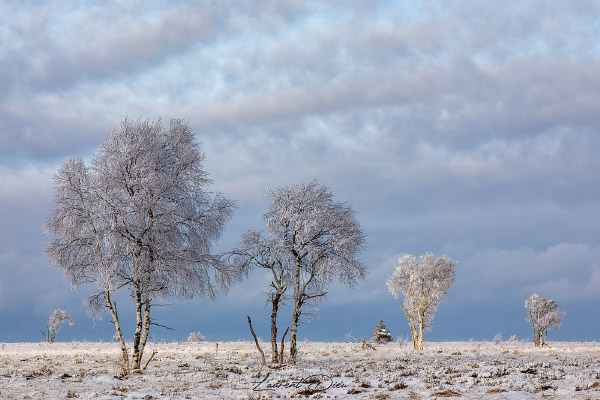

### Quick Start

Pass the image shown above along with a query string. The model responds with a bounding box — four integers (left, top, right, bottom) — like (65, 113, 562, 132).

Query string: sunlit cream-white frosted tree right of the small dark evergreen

(386, 253, 457, 350)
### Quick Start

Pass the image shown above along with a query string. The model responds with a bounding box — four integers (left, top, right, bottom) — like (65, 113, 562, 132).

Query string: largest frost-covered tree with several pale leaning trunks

(44, 119, 234, 369)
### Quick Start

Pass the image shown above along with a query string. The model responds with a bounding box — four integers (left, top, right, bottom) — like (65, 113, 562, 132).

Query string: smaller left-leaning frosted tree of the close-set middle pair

(231, 230, 290, 363)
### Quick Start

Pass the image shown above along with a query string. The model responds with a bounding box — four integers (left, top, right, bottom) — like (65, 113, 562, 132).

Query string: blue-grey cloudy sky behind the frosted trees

(0, 0, 600, 341)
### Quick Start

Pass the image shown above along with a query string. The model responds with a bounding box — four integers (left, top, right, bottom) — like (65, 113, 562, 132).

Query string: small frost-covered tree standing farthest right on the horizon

(525, 293, 566, 347)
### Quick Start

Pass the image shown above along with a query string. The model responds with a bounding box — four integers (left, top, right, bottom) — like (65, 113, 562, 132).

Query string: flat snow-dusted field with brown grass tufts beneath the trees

(0, 342, 600, 399)
